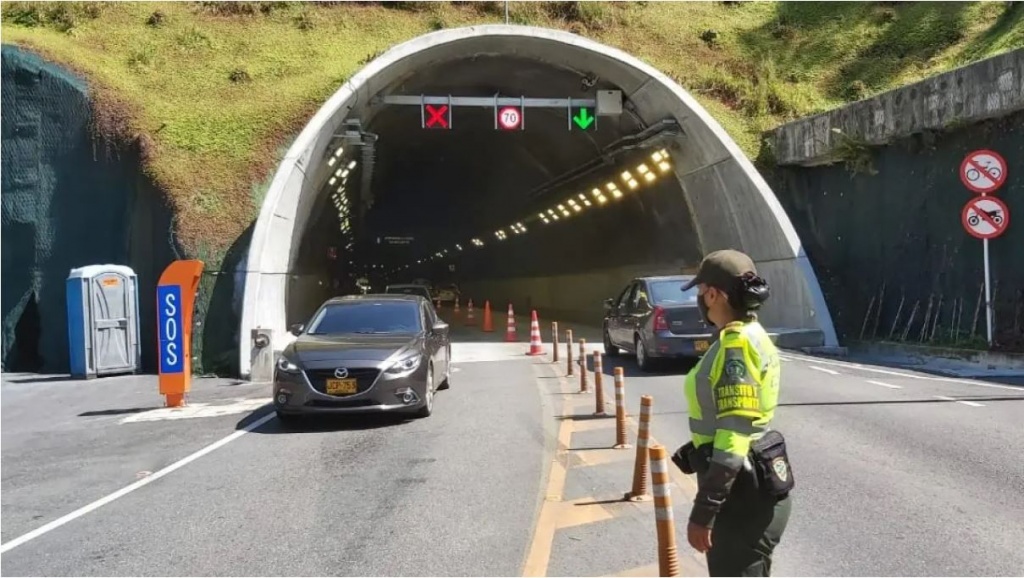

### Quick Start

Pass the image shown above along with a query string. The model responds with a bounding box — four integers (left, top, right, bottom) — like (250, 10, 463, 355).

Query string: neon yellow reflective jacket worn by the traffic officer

(685, 321, 781, 470)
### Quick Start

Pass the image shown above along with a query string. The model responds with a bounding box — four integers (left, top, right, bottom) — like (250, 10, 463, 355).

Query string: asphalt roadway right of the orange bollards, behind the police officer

(604, 354, 1024, 576)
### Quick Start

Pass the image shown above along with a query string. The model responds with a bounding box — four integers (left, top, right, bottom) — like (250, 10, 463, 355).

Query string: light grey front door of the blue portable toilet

(90, 272, 135, 374)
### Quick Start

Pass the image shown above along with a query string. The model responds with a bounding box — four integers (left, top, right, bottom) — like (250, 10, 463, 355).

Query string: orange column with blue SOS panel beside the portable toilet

(157, 259, 203, 408)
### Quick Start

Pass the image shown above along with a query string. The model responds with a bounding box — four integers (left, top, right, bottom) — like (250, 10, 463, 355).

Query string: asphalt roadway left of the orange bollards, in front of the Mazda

(2, 332, 553, 576)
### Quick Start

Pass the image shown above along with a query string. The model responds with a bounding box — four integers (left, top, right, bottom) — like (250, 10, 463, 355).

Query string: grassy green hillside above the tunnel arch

(2, 2, 1024, 257)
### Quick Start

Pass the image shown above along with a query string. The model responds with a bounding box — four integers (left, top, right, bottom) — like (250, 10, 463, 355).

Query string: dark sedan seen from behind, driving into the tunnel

(604, 275, 718, 371)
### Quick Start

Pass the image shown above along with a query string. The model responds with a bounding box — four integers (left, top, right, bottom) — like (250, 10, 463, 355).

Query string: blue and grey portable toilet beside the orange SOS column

(67, 264, 141, 379)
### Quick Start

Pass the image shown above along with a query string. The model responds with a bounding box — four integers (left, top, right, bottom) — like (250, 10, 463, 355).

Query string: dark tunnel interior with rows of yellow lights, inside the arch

(287, 54, 700, 323)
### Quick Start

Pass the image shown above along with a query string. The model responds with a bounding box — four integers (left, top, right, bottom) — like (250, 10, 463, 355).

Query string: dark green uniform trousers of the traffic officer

(706, 489, 793, 576)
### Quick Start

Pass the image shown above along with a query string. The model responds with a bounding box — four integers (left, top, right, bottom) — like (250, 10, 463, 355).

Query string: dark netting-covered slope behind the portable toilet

(0, 45, 174, 372)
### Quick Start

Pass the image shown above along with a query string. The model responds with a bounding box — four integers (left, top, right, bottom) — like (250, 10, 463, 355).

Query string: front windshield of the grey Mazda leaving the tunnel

(308, 300, 420, 335)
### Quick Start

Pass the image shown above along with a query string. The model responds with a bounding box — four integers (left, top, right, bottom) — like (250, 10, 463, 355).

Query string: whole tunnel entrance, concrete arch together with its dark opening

(240, 26, 836, 376)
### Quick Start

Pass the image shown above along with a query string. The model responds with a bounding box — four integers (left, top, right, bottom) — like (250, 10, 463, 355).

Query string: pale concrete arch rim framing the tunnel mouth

(239, 25, 838, 378)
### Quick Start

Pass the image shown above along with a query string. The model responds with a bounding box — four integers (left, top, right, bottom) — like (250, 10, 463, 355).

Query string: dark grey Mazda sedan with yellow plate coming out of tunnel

(273, 294, 452, 421)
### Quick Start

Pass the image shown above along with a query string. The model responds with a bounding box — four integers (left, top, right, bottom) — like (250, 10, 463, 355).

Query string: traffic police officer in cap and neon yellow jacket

(673, 250, 793, 576)
